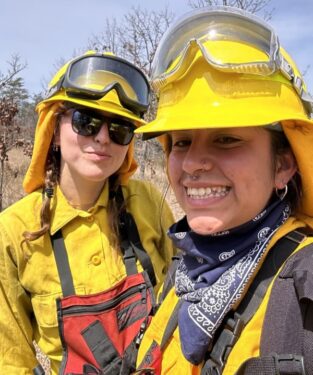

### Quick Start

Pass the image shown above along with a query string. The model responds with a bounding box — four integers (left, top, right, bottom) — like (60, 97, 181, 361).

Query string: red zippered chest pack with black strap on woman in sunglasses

(53, 231, 155, 375)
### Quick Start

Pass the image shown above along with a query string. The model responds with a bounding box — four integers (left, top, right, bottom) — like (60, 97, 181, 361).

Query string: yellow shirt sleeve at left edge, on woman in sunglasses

(0, 222, 38, 375)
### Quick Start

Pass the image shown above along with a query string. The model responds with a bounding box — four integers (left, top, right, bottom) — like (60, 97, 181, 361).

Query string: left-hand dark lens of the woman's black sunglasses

(72, 110, 103, 137)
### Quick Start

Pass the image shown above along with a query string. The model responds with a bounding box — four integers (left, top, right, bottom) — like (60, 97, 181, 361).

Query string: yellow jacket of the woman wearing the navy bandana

(137, 218, 313, 375)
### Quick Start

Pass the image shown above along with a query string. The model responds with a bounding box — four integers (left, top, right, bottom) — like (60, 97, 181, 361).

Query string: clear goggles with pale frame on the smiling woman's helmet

(151, 6, 312, 112)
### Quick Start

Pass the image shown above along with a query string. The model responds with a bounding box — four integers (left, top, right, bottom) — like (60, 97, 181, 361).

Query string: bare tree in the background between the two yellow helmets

(88, 7, 174, 181)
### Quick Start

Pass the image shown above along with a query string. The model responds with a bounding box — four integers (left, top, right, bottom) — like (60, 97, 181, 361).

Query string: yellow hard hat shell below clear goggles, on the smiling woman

(137, 41, 311, 133)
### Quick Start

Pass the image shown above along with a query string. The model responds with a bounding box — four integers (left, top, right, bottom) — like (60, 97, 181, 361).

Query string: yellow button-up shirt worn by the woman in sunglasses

(0, 181, 173, 375)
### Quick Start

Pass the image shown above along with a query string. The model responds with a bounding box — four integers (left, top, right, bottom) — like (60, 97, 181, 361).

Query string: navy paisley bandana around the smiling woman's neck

(168, 199, 290, 365)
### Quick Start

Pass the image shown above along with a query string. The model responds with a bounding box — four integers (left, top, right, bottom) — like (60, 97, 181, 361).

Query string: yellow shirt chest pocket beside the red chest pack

(32, 287, 85, 328)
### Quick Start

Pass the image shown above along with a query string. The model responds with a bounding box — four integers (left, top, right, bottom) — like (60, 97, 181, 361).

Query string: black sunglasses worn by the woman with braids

(72, 109, 136, 146)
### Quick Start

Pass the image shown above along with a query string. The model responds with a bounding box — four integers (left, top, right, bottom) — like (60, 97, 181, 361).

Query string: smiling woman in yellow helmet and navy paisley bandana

(137, 7, 313, 375)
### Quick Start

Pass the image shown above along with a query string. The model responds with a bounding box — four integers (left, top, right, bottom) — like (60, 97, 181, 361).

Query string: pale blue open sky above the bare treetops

(0, 0, 313, 93)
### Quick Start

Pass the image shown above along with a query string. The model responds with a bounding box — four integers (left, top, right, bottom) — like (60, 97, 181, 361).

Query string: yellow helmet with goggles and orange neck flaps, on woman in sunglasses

(23, 51, 150, 193)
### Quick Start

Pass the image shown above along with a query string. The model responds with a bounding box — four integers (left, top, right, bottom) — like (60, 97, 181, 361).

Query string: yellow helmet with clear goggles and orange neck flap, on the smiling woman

(136, 7, 313, 216)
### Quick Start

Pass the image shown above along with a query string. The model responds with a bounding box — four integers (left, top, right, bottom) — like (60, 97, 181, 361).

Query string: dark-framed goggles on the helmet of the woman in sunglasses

(46, 53, 150, 116)
